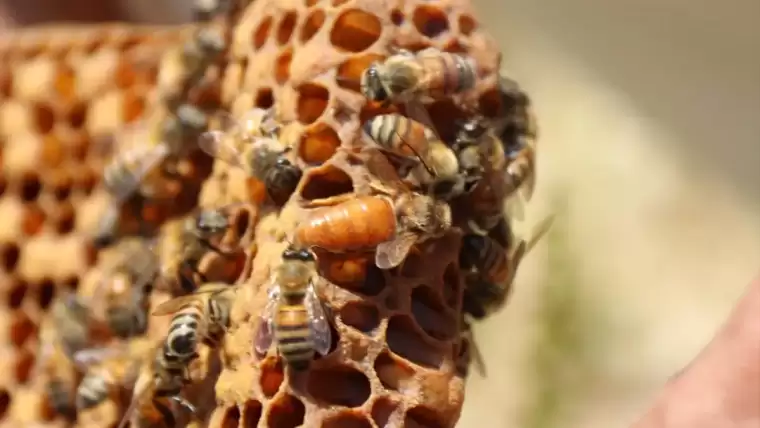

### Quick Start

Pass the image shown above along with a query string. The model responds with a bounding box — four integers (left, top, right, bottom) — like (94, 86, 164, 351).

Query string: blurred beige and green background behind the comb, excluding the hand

(0, 0, 760, 428)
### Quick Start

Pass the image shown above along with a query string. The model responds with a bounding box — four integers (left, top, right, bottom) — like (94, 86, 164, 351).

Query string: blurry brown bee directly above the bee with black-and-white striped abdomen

(158, 206, 240, 293)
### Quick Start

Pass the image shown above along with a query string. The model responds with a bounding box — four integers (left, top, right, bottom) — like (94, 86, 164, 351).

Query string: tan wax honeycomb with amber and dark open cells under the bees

(0, 0, 524, 428)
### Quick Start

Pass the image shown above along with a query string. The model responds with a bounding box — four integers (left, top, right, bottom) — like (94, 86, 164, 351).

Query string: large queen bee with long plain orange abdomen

(295, 150, 452, 269)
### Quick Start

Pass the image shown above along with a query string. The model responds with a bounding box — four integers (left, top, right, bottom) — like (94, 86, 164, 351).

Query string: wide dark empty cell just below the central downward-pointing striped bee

(307, 366, 371, 407)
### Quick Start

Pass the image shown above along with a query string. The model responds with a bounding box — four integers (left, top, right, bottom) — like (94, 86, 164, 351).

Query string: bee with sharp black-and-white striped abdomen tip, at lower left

(153, 283, 235, 366)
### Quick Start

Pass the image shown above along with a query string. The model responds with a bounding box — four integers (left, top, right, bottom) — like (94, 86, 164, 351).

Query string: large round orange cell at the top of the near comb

(330, 9, 383, 52)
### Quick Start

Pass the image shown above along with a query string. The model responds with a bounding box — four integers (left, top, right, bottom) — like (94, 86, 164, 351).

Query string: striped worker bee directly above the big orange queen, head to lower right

(363, 114, 479, 200)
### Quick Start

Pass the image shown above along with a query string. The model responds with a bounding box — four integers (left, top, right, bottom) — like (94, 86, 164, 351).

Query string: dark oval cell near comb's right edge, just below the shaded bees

(412, 285, 457, 340)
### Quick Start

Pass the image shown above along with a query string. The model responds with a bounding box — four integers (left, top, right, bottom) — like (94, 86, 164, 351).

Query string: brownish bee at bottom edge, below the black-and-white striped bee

(118, 345, 197, 428)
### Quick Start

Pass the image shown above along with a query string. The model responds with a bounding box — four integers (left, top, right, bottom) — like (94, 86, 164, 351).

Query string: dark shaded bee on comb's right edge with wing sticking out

(460, 216, 554, 319)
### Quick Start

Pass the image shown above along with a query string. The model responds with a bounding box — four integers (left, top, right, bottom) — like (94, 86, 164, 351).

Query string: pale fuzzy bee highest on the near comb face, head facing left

(361, 48, 477, 104)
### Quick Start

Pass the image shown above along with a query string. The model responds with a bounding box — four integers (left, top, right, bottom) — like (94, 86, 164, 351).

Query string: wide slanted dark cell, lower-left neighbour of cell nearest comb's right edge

(386, 315, 443, 369)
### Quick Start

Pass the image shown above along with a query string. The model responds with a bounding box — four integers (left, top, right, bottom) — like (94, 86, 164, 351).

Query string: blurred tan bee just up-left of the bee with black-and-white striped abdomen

(93, 240, 158, 339)
